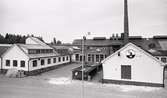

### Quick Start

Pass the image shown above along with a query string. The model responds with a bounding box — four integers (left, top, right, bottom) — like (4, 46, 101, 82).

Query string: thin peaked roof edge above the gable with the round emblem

(102, 43, 165, 66)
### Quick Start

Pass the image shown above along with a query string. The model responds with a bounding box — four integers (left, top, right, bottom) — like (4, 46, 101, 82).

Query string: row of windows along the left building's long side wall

(32, 56, 69, 67)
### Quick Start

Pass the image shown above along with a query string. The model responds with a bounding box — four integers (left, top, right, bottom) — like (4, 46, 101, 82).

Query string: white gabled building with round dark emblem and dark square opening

(102, 43, 165, 87)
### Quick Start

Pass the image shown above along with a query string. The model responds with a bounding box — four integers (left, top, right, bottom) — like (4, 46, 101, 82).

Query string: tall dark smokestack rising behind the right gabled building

(124, 0, 129, 44)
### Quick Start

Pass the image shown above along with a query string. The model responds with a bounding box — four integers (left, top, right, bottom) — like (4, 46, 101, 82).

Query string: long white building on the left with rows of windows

(1, 37, 70, 74)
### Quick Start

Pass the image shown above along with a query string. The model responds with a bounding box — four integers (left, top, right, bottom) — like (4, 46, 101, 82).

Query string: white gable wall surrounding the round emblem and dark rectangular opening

(103, 46, 163, 84)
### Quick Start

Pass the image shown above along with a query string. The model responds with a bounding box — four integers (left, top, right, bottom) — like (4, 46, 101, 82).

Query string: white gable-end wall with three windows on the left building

(2, 45, 28, 71)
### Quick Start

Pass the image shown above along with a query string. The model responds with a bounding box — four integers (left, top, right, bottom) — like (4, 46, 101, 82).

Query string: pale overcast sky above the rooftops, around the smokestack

(0, 0, 167, 43)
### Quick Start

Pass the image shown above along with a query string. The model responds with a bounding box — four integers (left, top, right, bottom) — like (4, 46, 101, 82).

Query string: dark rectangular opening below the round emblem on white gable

(121, 65, 131, 79)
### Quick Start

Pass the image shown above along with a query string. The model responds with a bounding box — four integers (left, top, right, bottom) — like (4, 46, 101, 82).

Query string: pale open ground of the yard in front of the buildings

(0, 64, 167, 98)
